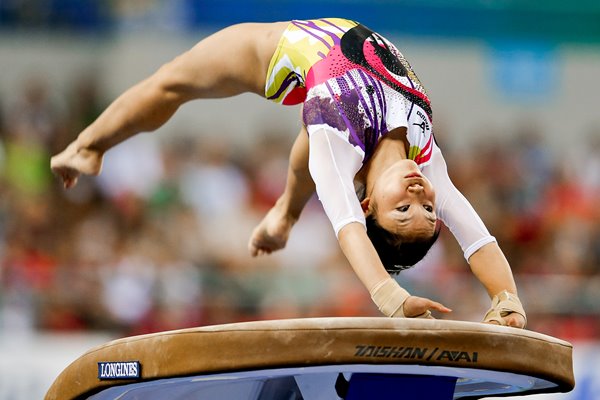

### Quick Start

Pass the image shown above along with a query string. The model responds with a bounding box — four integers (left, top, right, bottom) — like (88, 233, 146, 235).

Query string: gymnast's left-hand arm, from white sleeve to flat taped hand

(309, 128, 450, 317)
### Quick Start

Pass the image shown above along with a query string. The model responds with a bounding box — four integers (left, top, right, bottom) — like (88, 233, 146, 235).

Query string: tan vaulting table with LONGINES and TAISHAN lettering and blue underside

(45, 318, 575, 400)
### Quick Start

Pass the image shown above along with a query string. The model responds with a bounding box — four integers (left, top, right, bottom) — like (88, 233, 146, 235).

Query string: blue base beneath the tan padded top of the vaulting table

(89, 364, 556, 400)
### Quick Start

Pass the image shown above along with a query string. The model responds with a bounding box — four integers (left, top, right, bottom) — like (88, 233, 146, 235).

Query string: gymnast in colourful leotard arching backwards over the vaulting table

(51, 18, 526, 328)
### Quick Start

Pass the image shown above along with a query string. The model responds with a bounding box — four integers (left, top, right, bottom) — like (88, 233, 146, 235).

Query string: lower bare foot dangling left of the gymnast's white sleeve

(248, 204, 297, 257)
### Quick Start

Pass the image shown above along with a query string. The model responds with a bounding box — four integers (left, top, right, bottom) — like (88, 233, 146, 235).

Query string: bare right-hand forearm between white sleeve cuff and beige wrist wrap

(469, 242, 517, 298)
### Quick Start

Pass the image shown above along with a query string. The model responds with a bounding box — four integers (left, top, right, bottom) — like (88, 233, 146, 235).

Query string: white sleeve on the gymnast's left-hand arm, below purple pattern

(308, 128, 366, 236)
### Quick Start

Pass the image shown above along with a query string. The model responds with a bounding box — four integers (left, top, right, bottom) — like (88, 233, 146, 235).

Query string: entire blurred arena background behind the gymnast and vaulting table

(0, 0, 600, 399)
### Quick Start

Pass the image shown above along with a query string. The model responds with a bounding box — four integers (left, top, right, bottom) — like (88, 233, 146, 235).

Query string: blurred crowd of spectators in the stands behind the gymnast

(0, 72, 600, 339)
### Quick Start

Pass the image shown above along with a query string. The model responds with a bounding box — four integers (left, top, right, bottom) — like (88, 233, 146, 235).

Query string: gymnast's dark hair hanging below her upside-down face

(366, 215, 441, 274)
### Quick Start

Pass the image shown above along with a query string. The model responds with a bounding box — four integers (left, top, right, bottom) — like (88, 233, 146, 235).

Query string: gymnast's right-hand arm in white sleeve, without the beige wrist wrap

(423, 146, 525, 327)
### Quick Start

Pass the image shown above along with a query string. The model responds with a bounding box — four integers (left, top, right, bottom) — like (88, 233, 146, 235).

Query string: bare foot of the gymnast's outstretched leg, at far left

(50, 141, 103, 189)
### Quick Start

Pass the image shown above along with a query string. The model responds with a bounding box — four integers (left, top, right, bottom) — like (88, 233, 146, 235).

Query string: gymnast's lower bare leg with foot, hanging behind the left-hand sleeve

(248, 126, 315, 256)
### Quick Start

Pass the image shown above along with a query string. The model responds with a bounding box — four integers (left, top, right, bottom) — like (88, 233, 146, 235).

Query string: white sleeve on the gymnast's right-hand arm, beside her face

(423, 146, 496, 261)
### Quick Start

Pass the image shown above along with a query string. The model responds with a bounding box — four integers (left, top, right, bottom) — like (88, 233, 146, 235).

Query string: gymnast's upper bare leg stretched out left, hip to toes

(51, 22, 287, 187)
